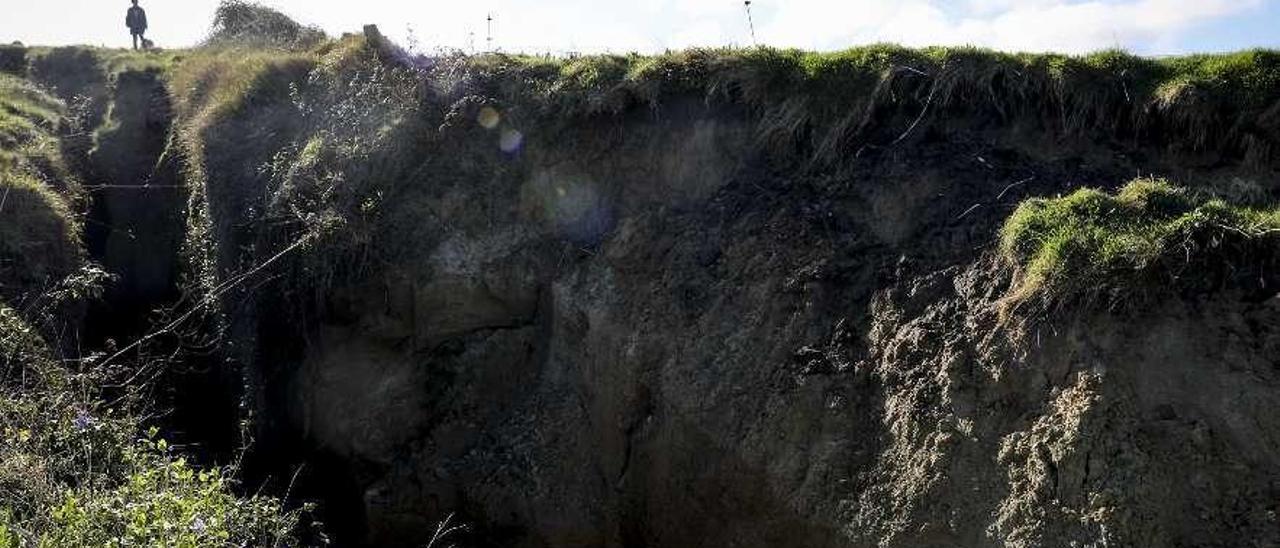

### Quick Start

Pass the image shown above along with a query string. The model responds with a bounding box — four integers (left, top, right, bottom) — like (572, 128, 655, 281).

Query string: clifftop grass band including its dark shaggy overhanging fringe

(434, 45, 1280, 164)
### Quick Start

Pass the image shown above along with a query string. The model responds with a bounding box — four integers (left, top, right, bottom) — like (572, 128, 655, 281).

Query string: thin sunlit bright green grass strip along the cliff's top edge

(468, 44, 1280, 114)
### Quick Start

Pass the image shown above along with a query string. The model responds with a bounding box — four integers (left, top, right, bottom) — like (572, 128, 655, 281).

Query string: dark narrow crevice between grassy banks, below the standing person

(73, 70, 239, 462)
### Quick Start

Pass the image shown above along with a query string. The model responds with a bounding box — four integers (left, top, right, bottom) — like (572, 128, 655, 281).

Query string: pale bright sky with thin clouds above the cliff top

(0, 0, 1280, 55)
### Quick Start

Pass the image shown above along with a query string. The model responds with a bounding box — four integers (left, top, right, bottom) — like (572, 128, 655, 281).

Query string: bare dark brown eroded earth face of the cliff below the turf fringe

(172, 41, 1280, 547)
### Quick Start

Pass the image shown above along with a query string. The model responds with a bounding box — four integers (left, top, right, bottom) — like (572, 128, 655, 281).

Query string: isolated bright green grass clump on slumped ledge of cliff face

(1000, 179, 1280, 306)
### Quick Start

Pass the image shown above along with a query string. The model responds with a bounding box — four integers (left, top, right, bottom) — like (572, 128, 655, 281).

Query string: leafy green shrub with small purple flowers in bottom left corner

(0, 302, 303, 547)
